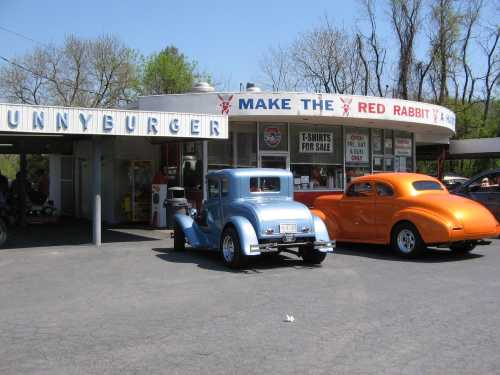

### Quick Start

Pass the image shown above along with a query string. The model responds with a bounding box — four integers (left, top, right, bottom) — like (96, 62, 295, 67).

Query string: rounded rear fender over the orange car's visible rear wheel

(387, 207, 451, 244)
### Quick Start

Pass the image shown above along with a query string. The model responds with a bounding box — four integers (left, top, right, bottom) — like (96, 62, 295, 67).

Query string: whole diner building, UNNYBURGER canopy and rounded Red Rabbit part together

(0, 84, 455, 239)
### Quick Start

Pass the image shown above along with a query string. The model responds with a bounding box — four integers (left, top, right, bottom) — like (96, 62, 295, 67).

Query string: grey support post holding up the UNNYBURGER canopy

(92, 137, 102, 246)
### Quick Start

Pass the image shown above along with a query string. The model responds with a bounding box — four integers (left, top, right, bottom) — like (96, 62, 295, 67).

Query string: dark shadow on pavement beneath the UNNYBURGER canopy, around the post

(0, 220, 162, 251)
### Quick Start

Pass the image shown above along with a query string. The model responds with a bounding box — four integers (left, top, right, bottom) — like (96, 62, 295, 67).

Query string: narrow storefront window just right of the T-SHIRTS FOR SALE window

(345, 127, 371, 183)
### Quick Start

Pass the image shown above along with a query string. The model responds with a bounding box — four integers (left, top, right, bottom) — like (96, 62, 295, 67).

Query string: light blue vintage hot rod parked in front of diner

(174, 168, 335, 267)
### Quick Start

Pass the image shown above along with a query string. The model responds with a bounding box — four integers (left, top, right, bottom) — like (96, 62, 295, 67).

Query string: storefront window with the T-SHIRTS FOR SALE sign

(290, 124, 344, 191)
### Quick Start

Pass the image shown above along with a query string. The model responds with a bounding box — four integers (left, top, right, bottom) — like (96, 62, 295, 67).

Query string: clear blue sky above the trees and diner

(0, 0, 497, 90)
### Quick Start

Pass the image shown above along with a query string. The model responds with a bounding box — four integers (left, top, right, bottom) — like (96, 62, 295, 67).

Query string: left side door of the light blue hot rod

(200, 177, 222, 247)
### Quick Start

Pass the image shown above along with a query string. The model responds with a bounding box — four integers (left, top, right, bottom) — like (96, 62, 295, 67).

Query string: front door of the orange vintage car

(339, 181, 376, 240)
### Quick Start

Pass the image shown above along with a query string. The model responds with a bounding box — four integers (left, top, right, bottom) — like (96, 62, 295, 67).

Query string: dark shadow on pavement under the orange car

(335, 243, 483, 263)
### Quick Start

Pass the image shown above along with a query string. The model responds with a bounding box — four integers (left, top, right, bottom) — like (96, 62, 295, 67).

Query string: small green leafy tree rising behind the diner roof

(143, 46, 199, 95)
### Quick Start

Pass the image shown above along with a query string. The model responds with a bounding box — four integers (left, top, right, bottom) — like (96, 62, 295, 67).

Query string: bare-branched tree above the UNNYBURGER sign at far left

(0, 35, 139, 107)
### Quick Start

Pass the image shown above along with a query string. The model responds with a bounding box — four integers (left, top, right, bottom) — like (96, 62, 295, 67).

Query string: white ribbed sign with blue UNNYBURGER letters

(0, 103, 228, 139)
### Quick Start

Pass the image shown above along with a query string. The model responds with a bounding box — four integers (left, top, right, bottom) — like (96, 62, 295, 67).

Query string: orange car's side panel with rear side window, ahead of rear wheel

(374, 182, 398, 240)
